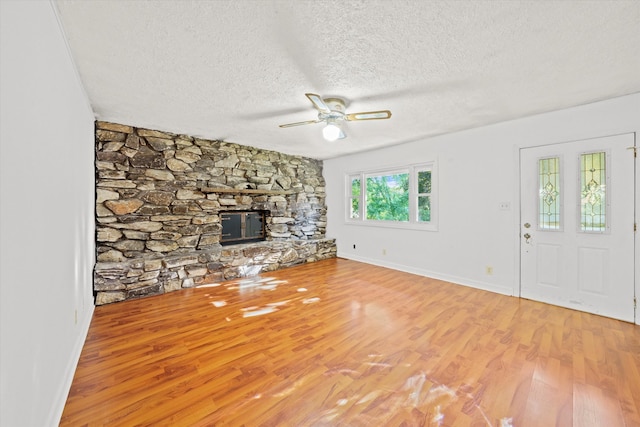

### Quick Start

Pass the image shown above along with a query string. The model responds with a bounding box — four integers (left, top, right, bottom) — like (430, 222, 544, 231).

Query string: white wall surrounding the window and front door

(324, 94, 640, 310)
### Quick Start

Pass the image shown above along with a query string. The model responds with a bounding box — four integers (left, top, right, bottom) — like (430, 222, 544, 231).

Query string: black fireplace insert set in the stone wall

(220, 211, 265, 246)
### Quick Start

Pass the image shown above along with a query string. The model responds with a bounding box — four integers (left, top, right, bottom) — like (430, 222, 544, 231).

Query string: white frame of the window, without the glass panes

(345, 161, 438, 231)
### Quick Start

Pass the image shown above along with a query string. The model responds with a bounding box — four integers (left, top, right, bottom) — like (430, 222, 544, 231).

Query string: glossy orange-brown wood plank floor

(61, 259, 640, 427)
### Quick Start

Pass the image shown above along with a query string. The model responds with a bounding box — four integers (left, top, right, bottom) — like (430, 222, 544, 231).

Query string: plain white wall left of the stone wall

(0, 0, 94, 427)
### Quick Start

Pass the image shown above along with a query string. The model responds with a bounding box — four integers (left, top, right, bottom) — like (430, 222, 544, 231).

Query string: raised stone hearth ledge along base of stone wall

(94, 238, 337, 305)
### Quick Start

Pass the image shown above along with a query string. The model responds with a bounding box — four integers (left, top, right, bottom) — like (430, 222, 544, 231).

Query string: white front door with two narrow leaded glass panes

(520, 134, 635, 322)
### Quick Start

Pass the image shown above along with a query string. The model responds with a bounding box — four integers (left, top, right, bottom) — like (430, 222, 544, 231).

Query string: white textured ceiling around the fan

(53, 0, 640, 159)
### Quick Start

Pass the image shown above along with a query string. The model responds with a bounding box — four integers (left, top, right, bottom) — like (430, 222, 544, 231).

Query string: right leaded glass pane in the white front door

(580, 152, 607, 232)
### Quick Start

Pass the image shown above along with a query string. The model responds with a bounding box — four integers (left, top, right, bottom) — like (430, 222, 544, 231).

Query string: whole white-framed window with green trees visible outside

(346, 163, 436, 230)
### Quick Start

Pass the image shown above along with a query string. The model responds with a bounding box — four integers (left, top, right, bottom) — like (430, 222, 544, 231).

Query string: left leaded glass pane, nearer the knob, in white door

(538, 157, 561, 230)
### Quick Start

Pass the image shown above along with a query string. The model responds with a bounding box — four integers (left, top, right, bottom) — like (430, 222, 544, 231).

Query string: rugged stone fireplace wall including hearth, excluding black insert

(94, 121, 336, 305)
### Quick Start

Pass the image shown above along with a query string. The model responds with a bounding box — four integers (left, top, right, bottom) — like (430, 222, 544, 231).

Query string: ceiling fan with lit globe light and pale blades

(280, 93, 391, 141)
